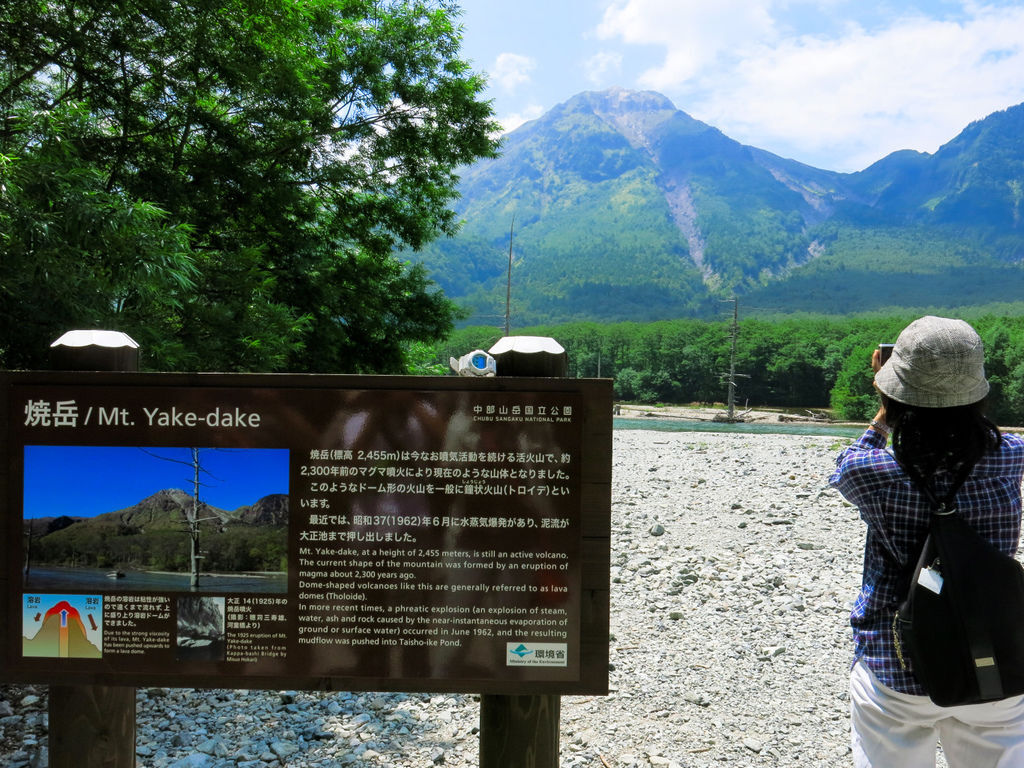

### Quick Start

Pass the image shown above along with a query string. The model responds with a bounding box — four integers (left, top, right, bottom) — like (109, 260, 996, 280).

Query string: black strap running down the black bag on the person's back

(901, 462, 1004, 700)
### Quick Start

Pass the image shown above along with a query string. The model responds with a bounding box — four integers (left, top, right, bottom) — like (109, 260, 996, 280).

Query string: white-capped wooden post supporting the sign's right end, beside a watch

(480, 336, 567, 768)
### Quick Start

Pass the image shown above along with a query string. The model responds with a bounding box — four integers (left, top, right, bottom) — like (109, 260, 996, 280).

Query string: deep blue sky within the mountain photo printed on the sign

(24, 445, 288, 518)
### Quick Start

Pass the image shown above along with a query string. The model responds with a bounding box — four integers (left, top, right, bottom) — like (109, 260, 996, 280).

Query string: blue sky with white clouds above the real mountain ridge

(460, 0, 1024, 171)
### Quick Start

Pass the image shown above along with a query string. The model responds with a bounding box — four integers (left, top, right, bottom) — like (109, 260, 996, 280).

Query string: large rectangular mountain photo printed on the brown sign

(23, 445, 289, 593)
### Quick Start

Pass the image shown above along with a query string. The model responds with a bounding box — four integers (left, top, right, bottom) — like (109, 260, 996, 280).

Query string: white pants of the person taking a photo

(850, 662, 1024, 768)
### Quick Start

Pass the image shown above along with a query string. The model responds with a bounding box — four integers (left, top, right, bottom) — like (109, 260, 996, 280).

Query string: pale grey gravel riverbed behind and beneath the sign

(0, 430, 942, 768)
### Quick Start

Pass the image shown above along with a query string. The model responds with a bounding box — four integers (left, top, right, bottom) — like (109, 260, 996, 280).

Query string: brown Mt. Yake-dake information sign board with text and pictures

(0, 372, 611, 694)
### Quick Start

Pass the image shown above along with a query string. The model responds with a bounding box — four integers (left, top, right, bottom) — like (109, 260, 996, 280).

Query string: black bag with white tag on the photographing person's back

(893, 467, 1024, 707)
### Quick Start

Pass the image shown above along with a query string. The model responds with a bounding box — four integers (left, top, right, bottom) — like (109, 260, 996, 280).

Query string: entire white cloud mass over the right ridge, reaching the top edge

(601, 0, 1024, 170)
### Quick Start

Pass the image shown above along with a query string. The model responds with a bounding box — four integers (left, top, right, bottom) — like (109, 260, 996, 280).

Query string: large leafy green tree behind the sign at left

(0, 0, 497, 372)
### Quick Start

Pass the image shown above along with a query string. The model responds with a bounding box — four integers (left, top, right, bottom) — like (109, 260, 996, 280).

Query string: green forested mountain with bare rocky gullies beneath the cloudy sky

(413, 89, 1024, 326)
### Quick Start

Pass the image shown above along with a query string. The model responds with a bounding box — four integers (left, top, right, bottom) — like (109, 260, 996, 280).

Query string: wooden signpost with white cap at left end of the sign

(49, 331, 138, 768)
